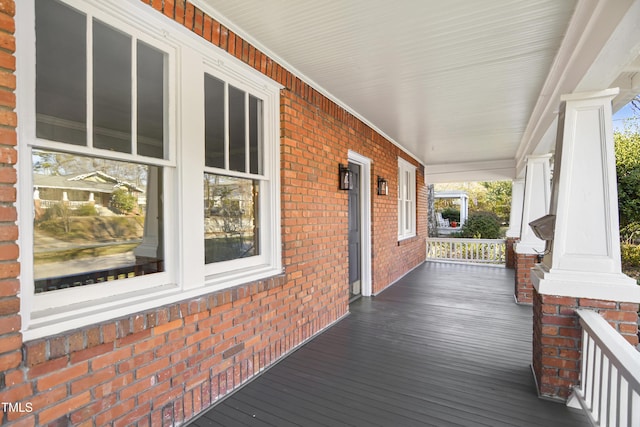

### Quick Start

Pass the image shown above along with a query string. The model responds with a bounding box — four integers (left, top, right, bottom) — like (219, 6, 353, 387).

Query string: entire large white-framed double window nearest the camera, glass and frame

(16, 0, 281, 340)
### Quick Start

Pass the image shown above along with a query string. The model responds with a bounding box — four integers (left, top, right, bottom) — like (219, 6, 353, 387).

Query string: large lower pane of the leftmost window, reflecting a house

(32, 151, 164, 292)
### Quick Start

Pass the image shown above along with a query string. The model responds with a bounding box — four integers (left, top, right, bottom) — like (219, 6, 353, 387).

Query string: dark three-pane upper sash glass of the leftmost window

(36, 1, 167, 159)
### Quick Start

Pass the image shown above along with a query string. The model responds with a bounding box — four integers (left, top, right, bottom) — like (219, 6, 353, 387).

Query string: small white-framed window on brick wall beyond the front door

(398, 158, 416, 240)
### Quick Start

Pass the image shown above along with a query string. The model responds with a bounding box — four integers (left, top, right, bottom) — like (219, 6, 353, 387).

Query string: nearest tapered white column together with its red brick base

(531, 89, 640, 400)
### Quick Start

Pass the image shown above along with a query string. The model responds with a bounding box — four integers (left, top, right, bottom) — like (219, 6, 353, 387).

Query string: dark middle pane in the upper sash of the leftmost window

(93, 20, 131, 153)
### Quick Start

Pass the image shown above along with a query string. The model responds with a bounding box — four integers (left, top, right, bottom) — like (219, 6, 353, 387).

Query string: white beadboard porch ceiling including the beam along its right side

(194, 0, 640, 182)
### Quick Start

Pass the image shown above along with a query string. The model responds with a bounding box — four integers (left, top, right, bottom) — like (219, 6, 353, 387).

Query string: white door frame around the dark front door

(348, 150, 372, 297)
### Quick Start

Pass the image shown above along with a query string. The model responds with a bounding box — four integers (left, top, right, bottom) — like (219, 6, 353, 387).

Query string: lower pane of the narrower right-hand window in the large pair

(204, 173, 260, 264)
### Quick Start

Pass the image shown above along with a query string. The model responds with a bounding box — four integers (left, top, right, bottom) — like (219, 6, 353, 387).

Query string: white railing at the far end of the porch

(427, 237, 506, 264)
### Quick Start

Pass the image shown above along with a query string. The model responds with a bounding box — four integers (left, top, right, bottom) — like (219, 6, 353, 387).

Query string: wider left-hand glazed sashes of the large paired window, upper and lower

(31, 1, 167, 293)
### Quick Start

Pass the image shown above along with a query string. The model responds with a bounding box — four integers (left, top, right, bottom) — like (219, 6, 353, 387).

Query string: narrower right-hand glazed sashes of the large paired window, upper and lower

(204, 74, 266, 264)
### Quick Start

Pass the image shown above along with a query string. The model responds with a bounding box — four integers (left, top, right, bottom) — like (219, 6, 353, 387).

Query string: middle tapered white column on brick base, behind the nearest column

(514, 154, 551, 304)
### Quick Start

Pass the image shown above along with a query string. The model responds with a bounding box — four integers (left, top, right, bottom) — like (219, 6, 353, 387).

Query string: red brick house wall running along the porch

(0, 0, 427, 426)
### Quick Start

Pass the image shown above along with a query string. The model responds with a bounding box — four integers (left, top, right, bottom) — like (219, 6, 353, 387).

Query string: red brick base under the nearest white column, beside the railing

(533, 289, 638, 401)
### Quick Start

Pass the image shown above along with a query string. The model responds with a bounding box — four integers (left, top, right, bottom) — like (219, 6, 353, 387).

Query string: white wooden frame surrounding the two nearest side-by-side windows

(16, 0, 282, 341)
